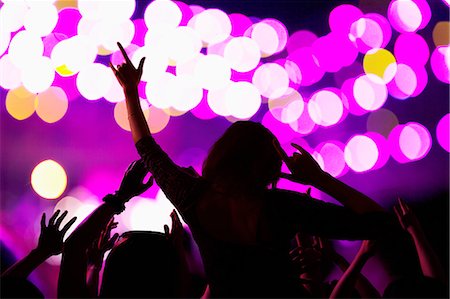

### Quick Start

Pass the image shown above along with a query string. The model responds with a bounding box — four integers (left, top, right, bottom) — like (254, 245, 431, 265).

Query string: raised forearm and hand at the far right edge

(394, 198, 448, 284)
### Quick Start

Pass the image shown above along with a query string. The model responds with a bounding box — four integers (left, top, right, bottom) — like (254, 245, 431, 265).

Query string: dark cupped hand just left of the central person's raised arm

(117, 160, 153, 201)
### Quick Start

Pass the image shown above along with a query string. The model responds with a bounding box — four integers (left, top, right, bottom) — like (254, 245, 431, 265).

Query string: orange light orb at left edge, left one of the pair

(6, 86, 36, 120)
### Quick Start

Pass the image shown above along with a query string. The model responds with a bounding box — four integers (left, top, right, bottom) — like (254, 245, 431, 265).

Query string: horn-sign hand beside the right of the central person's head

(273, 139, 324, 185)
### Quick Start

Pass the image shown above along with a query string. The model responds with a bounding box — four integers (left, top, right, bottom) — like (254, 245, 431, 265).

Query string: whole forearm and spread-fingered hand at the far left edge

(2, 210, 77, 279)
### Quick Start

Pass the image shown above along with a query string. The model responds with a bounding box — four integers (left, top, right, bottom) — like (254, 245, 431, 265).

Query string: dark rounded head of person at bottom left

(100, 231, 180, 298)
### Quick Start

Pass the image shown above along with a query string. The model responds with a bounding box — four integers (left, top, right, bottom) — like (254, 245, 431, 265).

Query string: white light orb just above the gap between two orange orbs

(22, 56, 55, 93)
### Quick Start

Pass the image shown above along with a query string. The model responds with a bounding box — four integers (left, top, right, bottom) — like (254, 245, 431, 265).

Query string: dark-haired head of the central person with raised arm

(203, 121, 281, 189)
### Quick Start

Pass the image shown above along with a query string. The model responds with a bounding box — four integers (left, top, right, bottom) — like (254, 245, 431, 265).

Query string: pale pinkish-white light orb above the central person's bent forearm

(344, 135, 379, 172)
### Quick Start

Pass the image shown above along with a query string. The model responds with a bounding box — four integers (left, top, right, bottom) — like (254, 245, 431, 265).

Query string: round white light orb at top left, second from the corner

(24, 3, 58, 36)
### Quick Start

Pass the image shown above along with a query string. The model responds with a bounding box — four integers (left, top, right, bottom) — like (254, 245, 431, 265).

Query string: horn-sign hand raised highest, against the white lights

(109, 43, 145, 89)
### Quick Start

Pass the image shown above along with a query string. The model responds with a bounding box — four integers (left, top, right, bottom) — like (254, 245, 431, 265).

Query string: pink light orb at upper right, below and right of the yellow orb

(387, 63, 417, 100)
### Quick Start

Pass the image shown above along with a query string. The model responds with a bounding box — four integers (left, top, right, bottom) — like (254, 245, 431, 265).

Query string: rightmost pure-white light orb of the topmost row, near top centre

(193, 9, 231, 44)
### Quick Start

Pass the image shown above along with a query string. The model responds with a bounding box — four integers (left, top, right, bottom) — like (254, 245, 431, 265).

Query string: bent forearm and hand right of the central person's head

(274, 140, 384, 214)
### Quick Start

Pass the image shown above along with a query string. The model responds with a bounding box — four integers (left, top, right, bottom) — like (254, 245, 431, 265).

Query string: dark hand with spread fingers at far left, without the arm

(36, 210, 77, 256)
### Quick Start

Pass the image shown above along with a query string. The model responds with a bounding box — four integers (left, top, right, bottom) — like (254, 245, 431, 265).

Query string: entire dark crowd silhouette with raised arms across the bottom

(1, 44, 448, 298)
